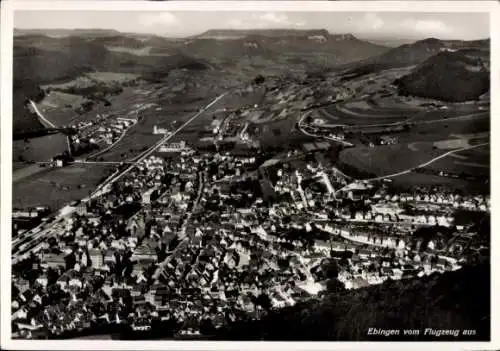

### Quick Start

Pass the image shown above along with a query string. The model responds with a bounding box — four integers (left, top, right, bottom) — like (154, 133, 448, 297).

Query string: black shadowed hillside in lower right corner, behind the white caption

(217, 264, 490, 341)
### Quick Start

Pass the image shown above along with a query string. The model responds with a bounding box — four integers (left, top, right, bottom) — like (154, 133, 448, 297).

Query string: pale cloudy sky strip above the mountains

(14, 10, 489, 40)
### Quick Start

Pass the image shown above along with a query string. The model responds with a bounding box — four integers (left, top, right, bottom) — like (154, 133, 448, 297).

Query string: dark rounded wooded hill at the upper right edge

(394, 49, 490, 102)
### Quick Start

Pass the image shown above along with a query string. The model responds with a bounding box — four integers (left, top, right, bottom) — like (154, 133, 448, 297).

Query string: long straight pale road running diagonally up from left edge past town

(12, 93, 227, 262)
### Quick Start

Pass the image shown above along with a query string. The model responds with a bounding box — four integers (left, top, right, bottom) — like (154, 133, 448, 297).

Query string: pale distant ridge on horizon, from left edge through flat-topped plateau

(15, 29, 387, 64)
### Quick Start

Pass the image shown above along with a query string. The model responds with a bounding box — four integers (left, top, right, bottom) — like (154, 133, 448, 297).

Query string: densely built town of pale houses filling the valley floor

(11, 132, 490, 338)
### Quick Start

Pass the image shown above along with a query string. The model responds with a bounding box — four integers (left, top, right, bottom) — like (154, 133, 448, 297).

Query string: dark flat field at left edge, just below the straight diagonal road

(12, 165, 111, 208)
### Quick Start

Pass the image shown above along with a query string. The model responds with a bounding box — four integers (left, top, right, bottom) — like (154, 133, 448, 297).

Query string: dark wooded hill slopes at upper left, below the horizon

(13, 31, 209, 130)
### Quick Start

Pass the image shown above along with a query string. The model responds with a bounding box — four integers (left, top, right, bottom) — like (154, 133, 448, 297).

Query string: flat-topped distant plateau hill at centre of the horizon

(169, 29, 388, 65)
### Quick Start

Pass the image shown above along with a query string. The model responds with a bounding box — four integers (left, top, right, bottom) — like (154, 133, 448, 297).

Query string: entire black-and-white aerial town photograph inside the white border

(6, 9, 491, 342)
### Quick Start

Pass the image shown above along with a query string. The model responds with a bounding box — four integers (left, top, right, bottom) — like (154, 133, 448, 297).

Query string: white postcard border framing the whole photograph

(0, 0, 500, 351)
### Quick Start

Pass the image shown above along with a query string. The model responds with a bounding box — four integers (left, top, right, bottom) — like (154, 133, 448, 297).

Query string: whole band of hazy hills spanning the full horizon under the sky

(14, 29, 489, 133)
